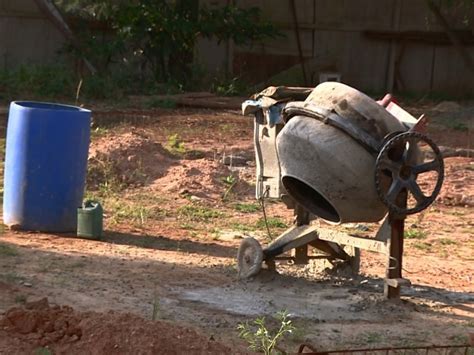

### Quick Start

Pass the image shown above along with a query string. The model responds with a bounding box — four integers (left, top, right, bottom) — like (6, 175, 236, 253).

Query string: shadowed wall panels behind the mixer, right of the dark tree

(198, 0, 474, 96)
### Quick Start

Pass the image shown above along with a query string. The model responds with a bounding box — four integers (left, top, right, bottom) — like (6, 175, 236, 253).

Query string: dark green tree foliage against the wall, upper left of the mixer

(56, 0, 280, 88)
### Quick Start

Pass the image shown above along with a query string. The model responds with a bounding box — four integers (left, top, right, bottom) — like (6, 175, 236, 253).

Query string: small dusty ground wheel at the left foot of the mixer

(237, 237, 263, 279)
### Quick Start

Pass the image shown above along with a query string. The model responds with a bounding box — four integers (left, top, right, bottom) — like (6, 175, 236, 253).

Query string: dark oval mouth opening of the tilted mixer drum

(282, 176, 341, 223)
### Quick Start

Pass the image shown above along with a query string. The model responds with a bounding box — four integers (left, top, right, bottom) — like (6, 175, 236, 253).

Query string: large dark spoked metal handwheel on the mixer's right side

(375, 132, 444, 216)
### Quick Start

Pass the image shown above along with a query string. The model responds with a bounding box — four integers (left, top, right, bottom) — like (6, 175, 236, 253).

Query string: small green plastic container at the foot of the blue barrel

(77, 201, 104, 239)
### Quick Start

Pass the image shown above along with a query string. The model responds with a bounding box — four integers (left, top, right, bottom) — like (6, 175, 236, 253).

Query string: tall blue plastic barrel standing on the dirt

(3, 101, 91, 232)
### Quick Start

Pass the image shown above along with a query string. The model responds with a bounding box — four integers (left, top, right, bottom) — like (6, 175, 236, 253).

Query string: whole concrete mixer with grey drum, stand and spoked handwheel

(237, 82, 444, 298)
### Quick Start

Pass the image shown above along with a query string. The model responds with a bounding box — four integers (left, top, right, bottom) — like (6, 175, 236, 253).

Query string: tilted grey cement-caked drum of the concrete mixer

(277, 82, 408, 223)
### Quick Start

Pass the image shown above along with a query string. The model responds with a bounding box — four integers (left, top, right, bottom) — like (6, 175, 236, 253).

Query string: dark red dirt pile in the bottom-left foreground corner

(0, 298, 239, 354)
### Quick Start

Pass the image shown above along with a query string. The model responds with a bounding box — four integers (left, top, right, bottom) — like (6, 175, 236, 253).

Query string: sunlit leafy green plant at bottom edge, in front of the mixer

(237, 311, 296, 355)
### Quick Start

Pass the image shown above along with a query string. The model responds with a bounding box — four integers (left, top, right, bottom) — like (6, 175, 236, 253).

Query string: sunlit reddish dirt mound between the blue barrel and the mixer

(87, 129, 248, 198)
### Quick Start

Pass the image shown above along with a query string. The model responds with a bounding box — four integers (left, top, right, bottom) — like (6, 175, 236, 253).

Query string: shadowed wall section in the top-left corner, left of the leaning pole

(0, 0, 64, 69)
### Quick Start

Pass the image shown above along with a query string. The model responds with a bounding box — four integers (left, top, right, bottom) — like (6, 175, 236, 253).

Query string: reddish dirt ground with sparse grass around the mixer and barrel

(0, 98, 474, 354)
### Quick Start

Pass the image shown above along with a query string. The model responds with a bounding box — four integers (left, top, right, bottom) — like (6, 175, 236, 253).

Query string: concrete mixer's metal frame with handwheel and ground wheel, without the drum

(237, 89, 444, 299)
